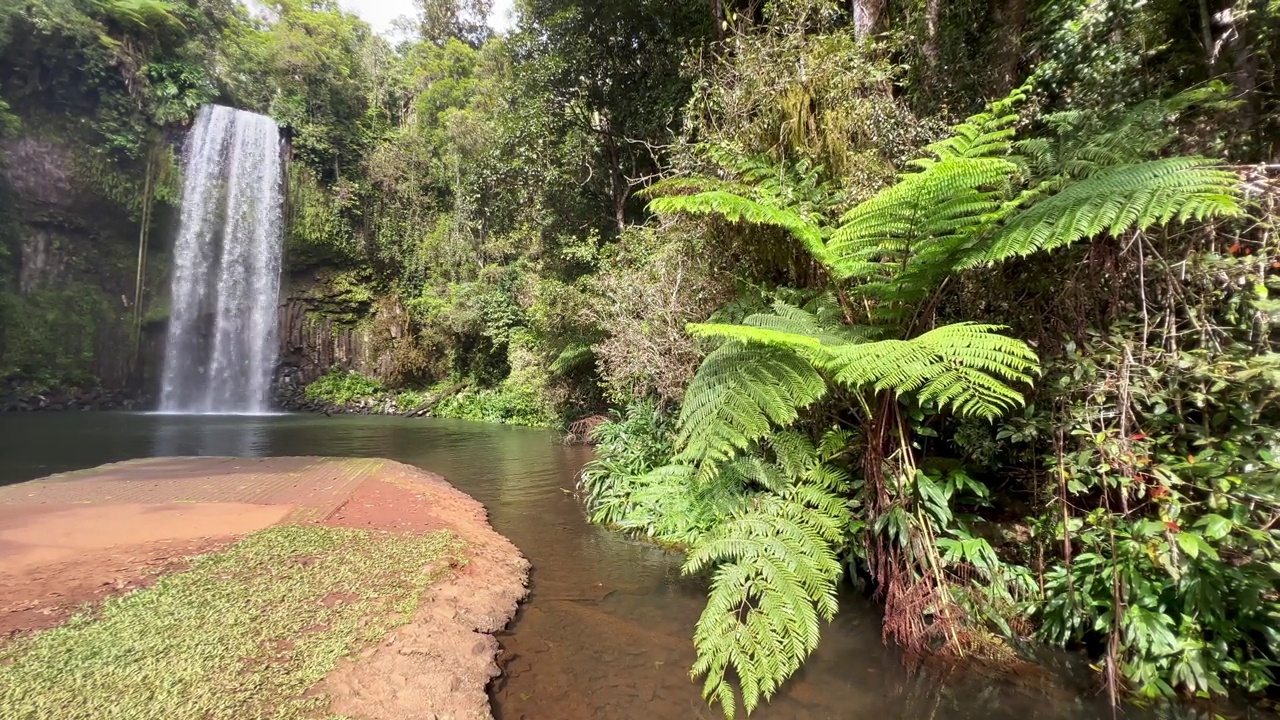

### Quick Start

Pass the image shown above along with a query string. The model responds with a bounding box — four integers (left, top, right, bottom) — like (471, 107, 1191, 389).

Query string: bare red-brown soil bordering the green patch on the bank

(0, 457, 529, 720)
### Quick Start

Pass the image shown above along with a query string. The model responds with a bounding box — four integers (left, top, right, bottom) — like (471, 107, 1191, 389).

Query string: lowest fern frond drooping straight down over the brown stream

(685, 433, 849, 717)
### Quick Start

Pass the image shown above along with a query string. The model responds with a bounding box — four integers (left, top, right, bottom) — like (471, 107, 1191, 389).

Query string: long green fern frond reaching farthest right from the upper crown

(960, 158, 1242, 268)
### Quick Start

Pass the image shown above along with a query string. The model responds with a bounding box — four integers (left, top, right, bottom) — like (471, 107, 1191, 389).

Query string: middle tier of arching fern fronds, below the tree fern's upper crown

(678, 316, 1037, 462)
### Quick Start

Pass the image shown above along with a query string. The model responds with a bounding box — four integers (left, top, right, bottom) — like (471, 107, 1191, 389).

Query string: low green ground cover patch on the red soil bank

(0, 527, 465, 720)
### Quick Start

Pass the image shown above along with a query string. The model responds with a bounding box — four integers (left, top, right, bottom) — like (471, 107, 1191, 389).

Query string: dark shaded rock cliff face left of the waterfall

(0, 133, 170, 400)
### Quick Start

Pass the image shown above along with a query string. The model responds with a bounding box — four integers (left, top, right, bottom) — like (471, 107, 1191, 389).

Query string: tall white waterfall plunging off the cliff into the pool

(160, 105, 284, 413)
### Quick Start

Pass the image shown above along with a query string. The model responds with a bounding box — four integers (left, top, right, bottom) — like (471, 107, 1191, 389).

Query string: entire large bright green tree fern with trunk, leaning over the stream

(634, 85, 1240, 716)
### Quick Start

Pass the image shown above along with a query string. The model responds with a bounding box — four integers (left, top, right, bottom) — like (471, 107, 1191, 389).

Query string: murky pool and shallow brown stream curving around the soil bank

(0, 413, 1187, 720)
